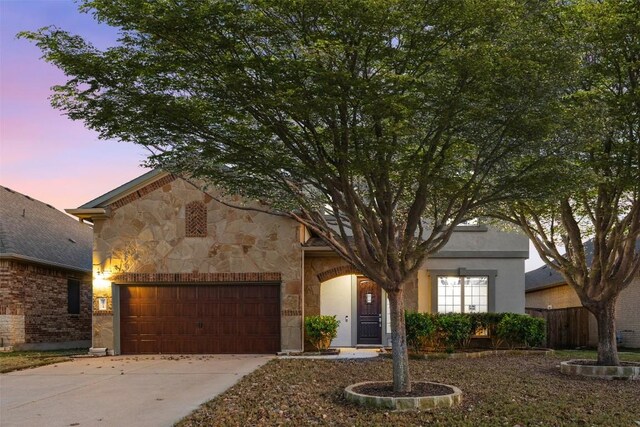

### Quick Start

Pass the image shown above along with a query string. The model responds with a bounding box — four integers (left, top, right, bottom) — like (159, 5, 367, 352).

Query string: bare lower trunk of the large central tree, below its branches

(387, 289, 411, 392)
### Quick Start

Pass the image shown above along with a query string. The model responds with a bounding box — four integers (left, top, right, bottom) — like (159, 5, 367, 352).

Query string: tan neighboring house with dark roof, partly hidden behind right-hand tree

(525, 241, 640, 348)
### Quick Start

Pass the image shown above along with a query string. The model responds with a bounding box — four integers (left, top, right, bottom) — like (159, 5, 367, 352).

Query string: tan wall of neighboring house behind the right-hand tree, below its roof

(526, 277, 640, 348)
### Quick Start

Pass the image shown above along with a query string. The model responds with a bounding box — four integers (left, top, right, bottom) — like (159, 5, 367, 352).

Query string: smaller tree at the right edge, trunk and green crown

(498, 0, 640, 365)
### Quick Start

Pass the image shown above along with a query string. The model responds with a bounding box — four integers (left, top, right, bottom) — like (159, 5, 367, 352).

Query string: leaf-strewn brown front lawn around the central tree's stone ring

(178, 354, 640, 427)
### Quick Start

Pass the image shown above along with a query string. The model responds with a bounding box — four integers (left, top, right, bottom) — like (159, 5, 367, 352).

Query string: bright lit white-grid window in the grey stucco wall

(437, 276, 489, 313)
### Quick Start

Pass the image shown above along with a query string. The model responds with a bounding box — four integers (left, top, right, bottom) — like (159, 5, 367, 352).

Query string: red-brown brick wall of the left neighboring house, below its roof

(0, 260, 91, 347)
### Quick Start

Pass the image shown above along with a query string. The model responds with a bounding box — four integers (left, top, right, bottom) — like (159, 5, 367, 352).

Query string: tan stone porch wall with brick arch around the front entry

(304, 252, 418, 316)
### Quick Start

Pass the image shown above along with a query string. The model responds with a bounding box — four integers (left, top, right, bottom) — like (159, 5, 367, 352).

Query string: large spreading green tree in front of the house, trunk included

(23, 0, 563, 391)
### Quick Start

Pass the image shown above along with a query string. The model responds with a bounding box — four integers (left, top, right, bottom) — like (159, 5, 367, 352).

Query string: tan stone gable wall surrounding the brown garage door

(93, 176, 302, 350)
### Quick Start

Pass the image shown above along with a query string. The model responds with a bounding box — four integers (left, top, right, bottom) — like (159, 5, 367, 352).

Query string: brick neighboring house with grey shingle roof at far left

(0, 186, 93, 349)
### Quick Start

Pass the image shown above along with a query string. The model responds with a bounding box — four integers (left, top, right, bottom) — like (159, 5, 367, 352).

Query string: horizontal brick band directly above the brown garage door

(111, 273, 282, 283)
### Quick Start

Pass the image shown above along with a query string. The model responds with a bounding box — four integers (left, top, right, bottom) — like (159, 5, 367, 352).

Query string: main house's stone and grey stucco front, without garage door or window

(77, 171, 528, 352)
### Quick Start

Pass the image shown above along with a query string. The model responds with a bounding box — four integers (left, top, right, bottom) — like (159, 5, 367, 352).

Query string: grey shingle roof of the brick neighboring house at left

(0, 186, 93, 271)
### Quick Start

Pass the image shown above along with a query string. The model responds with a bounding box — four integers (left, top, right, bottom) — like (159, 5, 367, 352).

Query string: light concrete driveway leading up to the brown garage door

(0, 355, 271, 427)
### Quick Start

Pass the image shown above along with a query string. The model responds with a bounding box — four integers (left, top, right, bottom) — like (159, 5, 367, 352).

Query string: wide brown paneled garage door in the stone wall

(120, 284, 280, 354)
